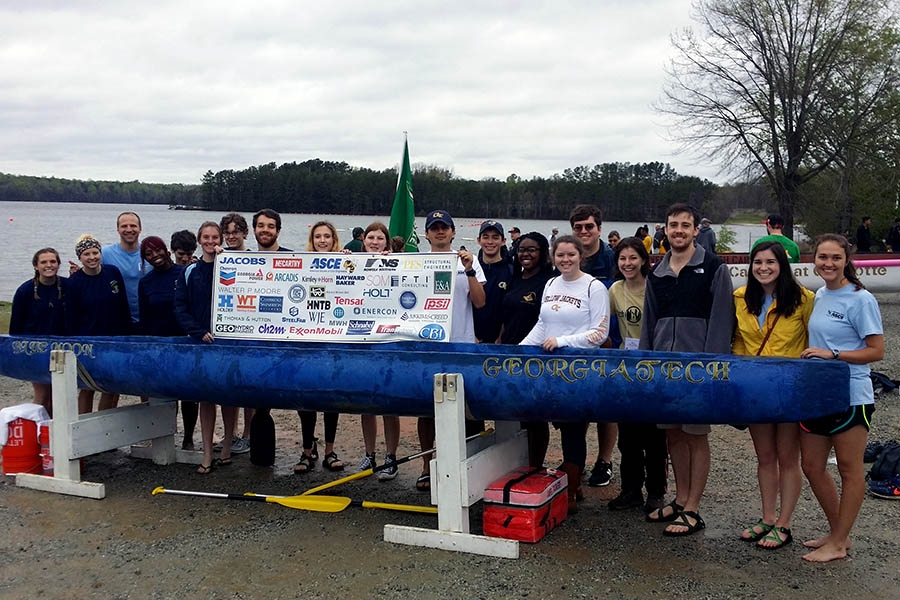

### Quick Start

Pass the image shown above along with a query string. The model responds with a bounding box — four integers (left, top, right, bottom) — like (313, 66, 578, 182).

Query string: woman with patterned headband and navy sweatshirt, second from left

(66, 235, 131, 414)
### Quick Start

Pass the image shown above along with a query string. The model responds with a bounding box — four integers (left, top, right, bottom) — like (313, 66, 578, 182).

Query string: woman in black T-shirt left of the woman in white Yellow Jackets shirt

(500, 231, 553, 468)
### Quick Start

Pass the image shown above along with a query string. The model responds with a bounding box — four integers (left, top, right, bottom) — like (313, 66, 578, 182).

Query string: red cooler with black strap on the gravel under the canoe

(484, 467, 569, 542)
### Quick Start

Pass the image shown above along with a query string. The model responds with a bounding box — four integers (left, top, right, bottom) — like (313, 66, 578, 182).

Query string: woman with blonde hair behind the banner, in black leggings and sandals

(294, 221, 349, 475)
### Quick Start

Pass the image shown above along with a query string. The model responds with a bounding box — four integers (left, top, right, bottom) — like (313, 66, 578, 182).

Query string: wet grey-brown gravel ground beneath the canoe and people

(0, 294, 900, 599)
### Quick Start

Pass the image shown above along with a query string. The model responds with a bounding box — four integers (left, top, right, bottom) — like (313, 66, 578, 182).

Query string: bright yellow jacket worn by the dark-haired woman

(731, 286, 815, 358)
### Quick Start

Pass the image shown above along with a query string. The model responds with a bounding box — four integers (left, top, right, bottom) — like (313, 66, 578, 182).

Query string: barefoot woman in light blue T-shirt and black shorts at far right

(800, 233, 884, 562)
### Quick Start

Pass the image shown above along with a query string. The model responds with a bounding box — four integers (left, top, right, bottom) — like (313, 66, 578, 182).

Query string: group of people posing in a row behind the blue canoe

(10, 204, 884, 562)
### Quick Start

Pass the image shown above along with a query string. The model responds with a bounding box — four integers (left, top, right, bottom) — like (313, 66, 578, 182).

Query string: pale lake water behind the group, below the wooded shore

(0, 202, 766, 301)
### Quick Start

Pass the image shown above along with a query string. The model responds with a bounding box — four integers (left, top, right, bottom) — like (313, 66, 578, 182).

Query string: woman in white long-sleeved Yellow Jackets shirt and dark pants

(520, 235, 609, 513)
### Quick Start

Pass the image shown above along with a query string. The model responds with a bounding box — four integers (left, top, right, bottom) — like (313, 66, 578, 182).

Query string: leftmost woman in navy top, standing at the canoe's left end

(9, 248, 68, 417)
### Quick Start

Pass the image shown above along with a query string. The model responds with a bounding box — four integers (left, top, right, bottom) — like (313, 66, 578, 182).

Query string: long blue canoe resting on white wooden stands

(0, 336, 849, 423)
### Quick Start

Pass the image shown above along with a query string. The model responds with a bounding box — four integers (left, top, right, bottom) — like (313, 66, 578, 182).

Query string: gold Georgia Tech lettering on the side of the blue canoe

(482, 356, 731, 383)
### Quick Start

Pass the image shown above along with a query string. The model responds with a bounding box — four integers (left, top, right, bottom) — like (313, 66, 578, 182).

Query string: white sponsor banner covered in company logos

(212, 251, 457, 342)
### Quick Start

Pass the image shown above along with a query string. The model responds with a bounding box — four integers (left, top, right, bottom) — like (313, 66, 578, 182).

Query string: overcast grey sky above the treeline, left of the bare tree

(0, 0, 722, 183)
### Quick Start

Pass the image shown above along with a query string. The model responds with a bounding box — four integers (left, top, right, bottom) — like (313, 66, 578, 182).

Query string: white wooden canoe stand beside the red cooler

(384, 373, 528, 558)
